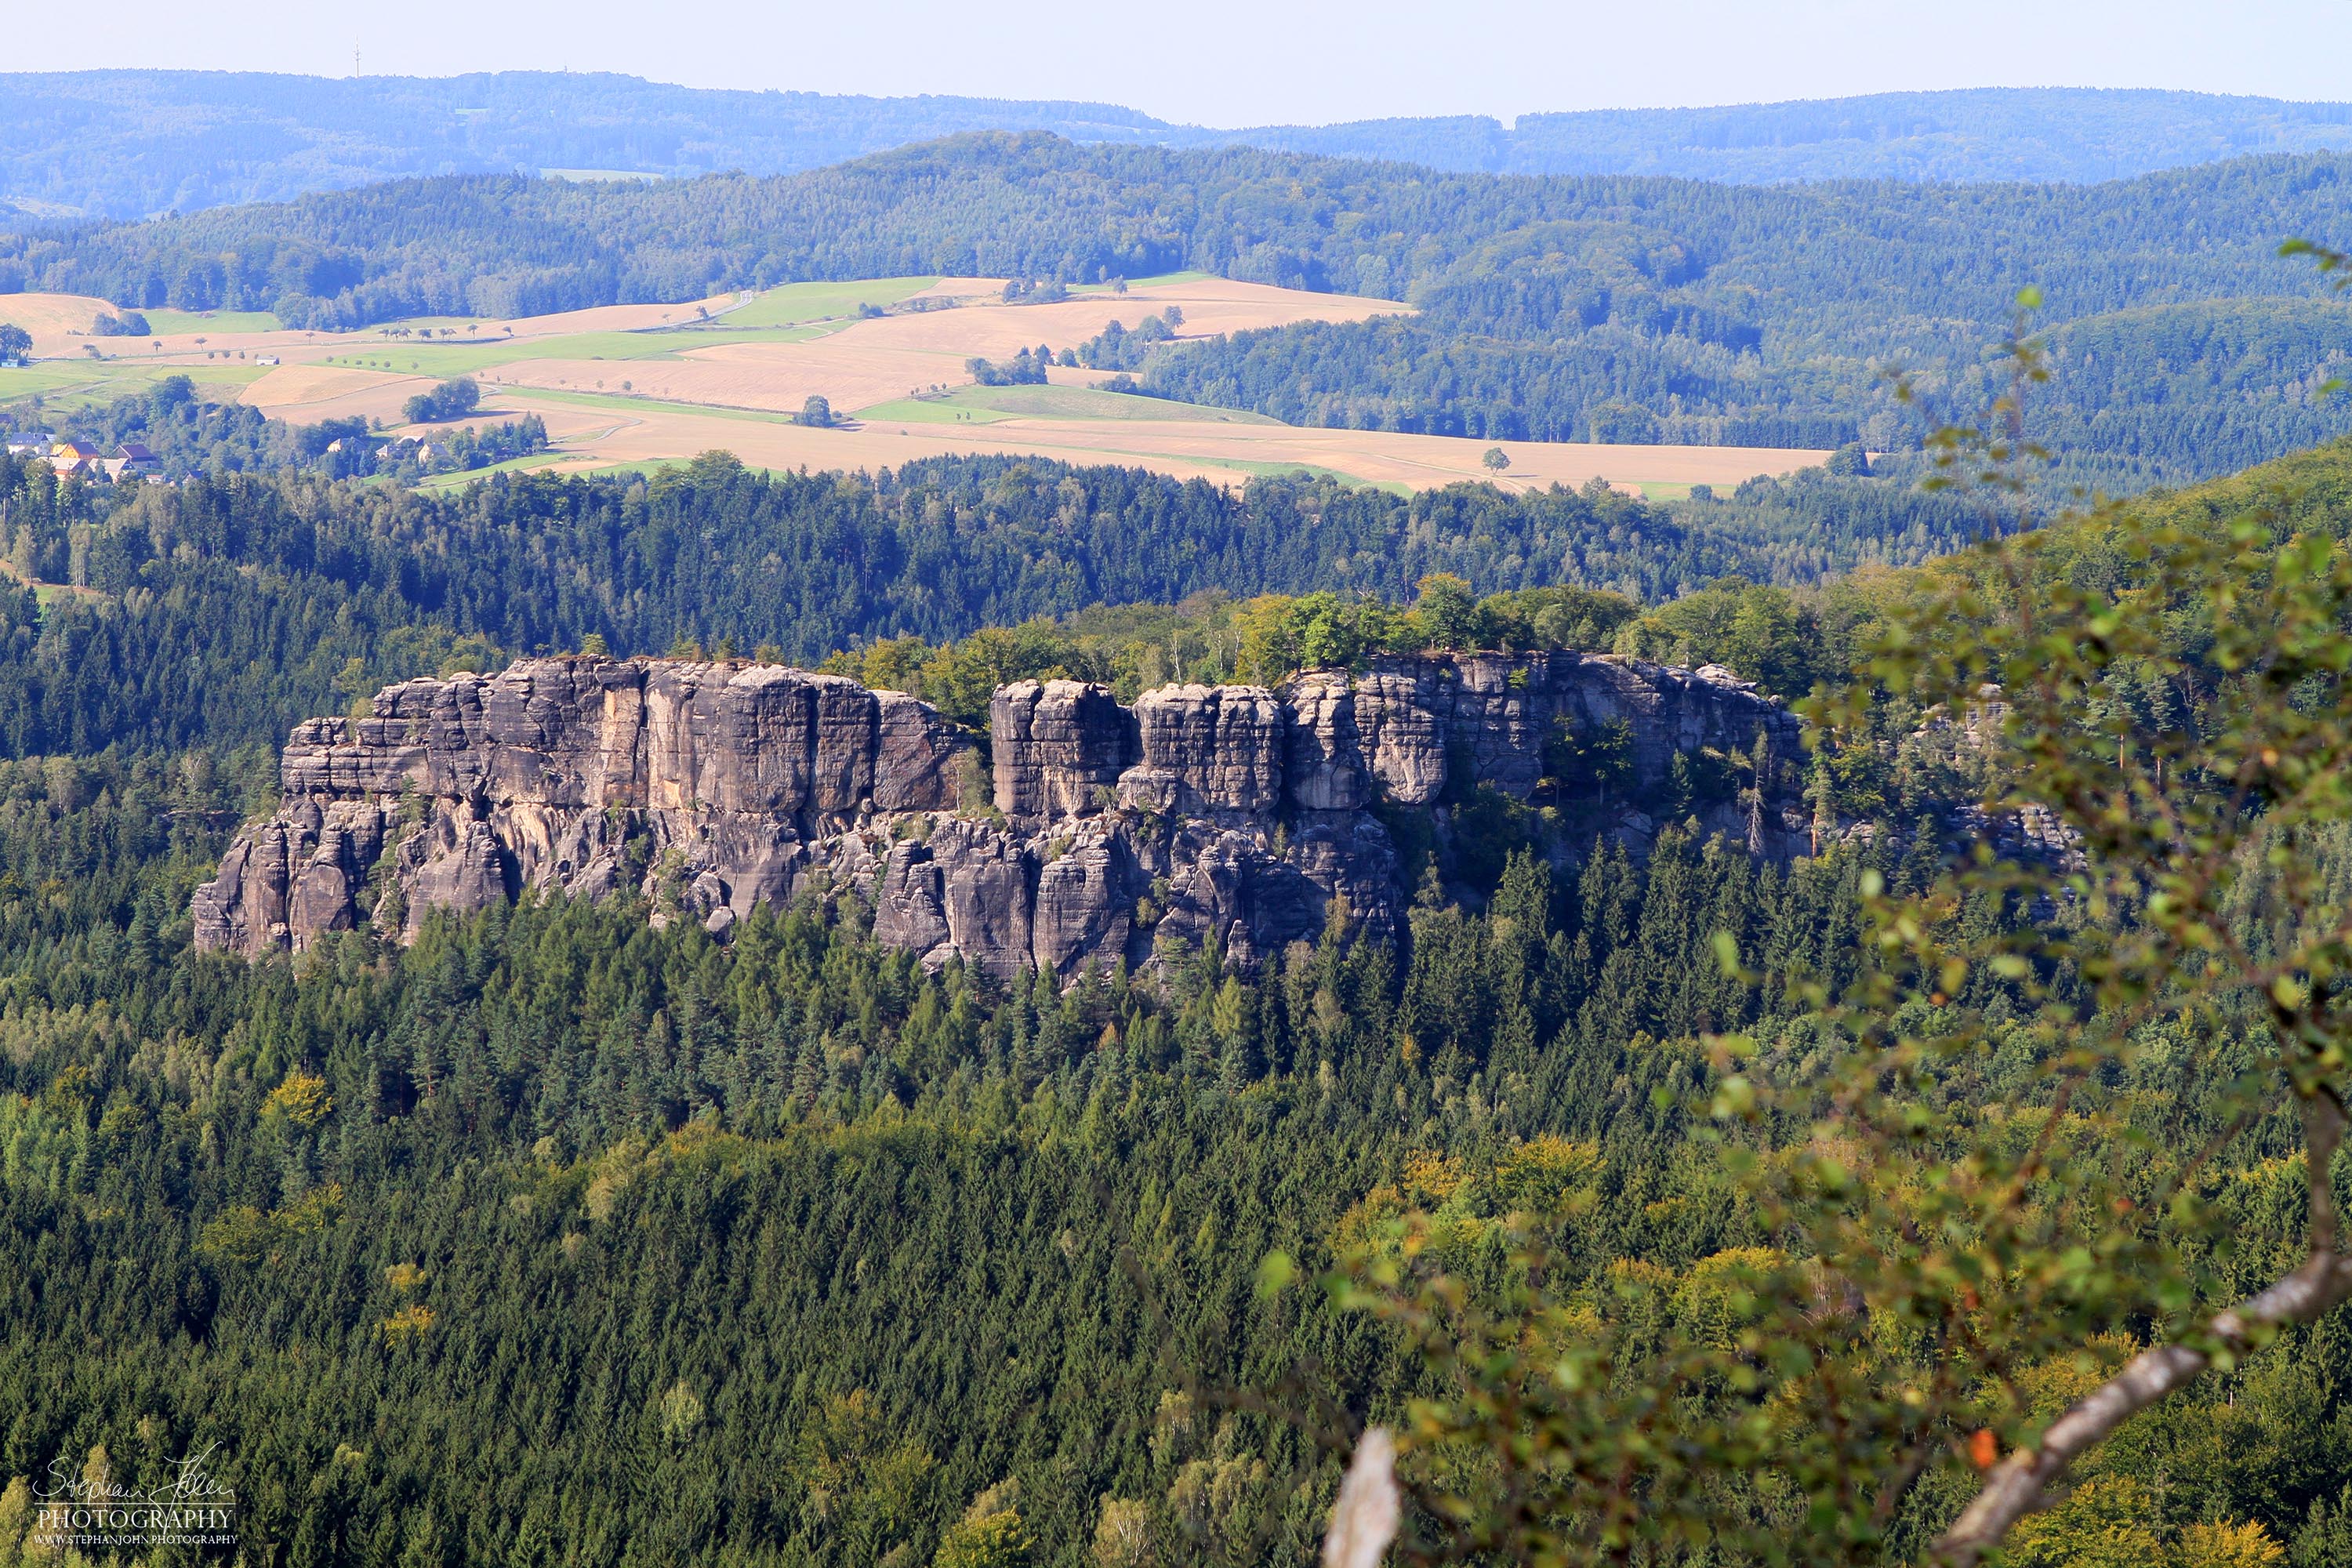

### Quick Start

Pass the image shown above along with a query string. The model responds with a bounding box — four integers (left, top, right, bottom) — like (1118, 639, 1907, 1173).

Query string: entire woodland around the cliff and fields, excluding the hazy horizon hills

(0, 89, 2352, 1568)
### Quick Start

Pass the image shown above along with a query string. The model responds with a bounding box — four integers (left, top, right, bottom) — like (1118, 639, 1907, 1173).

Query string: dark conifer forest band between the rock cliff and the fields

(0, 423, 1980, 755)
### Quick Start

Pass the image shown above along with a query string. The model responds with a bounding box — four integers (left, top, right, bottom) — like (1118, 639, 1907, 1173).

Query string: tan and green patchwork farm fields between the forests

(0, 275, 1823, 494)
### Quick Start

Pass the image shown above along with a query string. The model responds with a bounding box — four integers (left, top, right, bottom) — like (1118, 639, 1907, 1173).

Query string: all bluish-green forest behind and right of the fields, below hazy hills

(0, 134, 2352, 489)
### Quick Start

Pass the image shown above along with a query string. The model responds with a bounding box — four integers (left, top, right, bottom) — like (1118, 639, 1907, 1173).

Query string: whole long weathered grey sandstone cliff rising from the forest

(193, 654, 1804, 975)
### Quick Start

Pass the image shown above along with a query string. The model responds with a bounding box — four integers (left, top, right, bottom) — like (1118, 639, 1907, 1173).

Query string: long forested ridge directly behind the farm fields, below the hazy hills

(18, 134, 2343, 333)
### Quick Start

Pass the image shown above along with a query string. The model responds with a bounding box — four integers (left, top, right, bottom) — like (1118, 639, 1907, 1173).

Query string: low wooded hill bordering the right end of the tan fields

(1143, 299, 2352, 494)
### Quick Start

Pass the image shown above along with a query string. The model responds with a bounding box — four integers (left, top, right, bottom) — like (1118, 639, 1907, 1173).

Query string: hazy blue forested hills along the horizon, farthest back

(13, 71, 2352, 221)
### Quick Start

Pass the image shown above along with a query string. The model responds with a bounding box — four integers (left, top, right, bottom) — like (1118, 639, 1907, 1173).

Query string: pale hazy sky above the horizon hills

(80, 0, 2352, 127)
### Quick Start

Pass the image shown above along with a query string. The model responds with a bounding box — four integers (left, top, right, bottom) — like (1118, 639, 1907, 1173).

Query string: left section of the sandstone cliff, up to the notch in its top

(193, 659, 971, 954)
